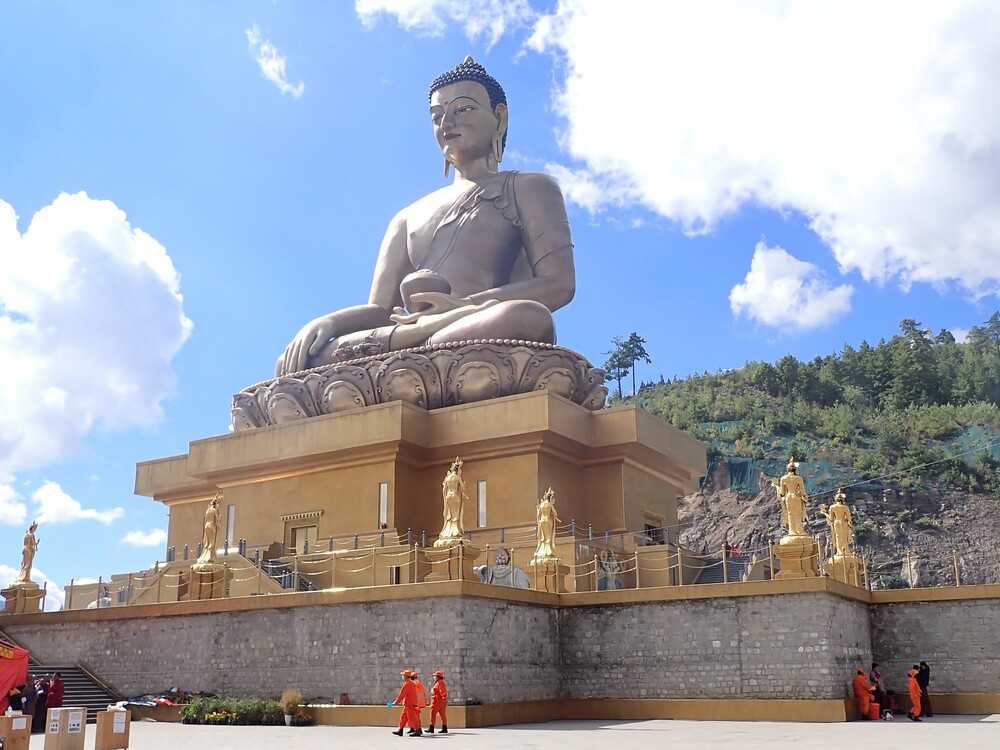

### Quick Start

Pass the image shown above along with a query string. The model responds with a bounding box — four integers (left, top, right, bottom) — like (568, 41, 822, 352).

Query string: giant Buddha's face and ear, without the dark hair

(431, 81, 507, 168)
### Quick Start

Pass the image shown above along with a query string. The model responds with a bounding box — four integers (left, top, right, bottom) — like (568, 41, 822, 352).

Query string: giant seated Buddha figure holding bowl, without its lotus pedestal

(277, 57, 575, 376)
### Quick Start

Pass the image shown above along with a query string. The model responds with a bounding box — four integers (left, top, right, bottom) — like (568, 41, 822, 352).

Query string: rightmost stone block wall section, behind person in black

(871, 599, 1000, 693)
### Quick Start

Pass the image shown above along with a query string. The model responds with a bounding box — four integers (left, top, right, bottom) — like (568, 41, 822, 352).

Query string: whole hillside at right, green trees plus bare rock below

(636, 313, 1000, 592)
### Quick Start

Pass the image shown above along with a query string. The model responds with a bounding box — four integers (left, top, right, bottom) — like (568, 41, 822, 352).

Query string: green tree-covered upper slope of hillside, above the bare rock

(635, 312, 1000, 494)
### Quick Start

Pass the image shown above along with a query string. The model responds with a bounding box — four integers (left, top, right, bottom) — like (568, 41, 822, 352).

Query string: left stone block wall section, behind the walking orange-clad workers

(7, 597, 559, 705)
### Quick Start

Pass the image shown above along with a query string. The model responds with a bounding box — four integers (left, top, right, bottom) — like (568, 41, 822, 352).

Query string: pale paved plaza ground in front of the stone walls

(21, 714, 1000, 750)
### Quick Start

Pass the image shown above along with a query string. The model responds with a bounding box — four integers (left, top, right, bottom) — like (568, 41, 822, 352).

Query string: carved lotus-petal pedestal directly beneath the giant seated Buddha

(232, 339, 607, 432)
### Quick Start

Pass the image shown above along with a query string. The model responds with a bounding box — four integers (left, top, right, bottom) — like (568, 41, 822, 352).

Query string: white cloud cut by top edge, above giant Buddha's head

(354, 0, 536, 46)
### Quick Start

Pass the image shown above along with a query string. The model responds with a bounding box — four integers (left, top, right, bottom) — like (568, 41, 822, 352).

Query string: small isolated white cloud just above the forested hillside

(729, 242, 854, 330)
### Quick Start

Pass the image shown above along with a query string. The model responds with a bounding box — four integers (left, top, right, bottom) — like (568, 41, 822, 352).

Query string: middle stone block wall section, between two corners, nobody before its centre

(560, 593, 871, 699)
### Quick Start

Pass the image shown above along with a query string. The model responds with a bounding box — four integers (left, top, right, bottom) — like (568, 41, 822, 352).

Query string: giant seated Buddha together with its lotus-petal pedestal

(233, 57, 604, 429)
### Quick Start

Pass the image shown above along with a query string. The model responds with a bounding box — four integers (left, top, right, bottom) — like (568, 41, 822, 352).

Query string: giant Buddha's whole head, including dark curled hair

(429, 57, 507, 169)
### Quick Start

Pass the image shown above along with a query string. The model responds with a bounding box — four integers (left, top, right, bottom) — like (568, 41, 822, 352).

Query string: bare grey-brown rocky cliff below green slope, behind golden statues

(678, 468, 1000, 588)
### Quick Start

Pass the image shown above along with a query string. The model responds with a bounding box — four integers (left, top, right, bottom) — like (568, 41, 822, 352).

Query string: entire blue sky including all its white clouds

(0, 0, 1000, 607)
